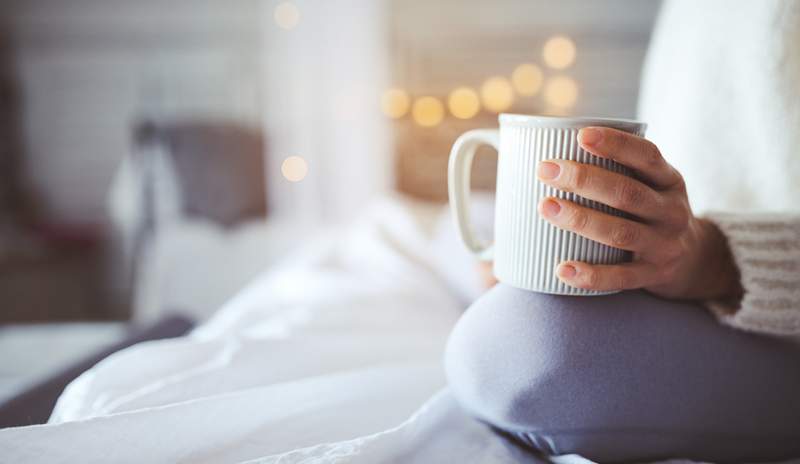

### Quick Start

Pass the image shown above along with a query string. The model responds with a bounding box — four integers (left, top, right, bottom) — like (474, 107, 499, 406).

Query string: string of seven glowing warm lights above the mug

(381, 35, 579, 127)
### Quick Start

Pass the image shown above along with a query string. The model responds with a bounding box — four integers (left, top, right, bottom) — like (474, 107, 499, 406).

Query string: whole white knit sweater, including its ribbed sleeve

(639, 0, 800, 335)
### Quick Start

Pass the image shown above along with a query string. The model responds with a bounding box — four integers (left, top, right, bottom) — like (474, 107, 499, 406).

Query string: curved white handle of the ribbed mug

(447, 129, 500, 261)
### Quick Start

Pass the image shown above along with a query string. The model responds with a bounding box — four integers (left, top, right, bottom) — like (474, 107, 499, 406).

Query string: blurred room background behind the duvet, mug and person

(0, 0, 659, 399)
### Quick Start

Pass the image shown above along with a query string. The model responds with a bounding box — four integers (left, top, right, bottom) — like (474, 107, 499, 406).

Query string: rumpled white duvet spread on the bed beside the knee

(0, 195, 556, 463)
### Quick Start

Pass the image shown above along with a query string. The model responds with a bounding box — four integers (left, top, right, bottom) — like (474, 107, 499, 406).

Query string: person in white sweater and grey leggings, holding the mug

(445, 0, 800, 462)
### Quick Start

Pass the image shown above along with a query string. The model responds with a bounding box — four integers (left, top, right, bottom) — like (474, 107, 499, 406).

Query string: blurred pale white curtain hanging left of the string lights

(263, 0, 393, 225)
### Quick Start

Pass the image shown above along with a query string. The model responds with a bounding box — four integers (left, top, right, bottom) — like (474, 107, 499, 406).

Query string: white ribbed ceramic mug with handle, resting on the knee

(448, 114, 647, 295)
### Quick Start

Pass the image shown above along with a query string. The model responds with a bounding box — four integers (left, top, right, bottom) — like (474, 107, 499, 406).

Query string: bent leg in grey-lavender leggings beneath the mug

(445, 284, 800, 462)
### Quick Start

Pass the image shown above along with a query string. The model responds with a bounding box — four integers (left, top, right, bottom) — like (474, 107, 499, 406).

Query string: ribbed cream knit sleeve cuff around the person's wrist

(706, 213, 800, 336)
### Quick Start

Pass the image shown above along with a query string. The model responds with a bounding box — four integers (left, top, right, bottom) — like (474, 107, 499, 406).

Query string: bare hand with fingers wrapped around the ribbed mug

(537, 127, 741, 299)
